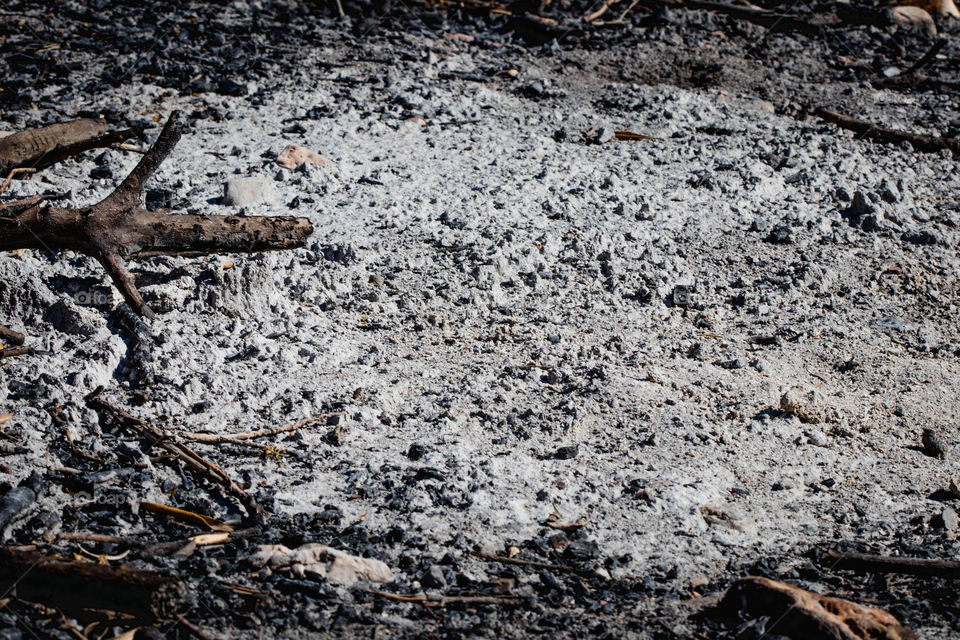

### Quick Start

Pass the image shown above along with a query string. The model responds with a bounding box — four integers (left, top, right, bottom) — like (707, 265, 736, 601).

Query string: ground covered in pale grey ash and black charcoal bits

(0, 2, 960, 638)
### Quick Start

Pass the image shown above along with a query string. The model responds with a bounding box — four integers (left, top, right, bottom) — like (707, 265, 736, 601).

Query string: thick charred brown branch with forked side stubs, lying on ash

(0, 112, 313, 318)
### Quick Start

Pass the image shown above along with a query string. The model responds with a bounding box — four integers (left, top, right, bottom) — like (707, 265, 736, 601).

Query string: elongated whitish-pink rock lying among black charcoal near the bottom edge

(250, 543, 393, 585)
